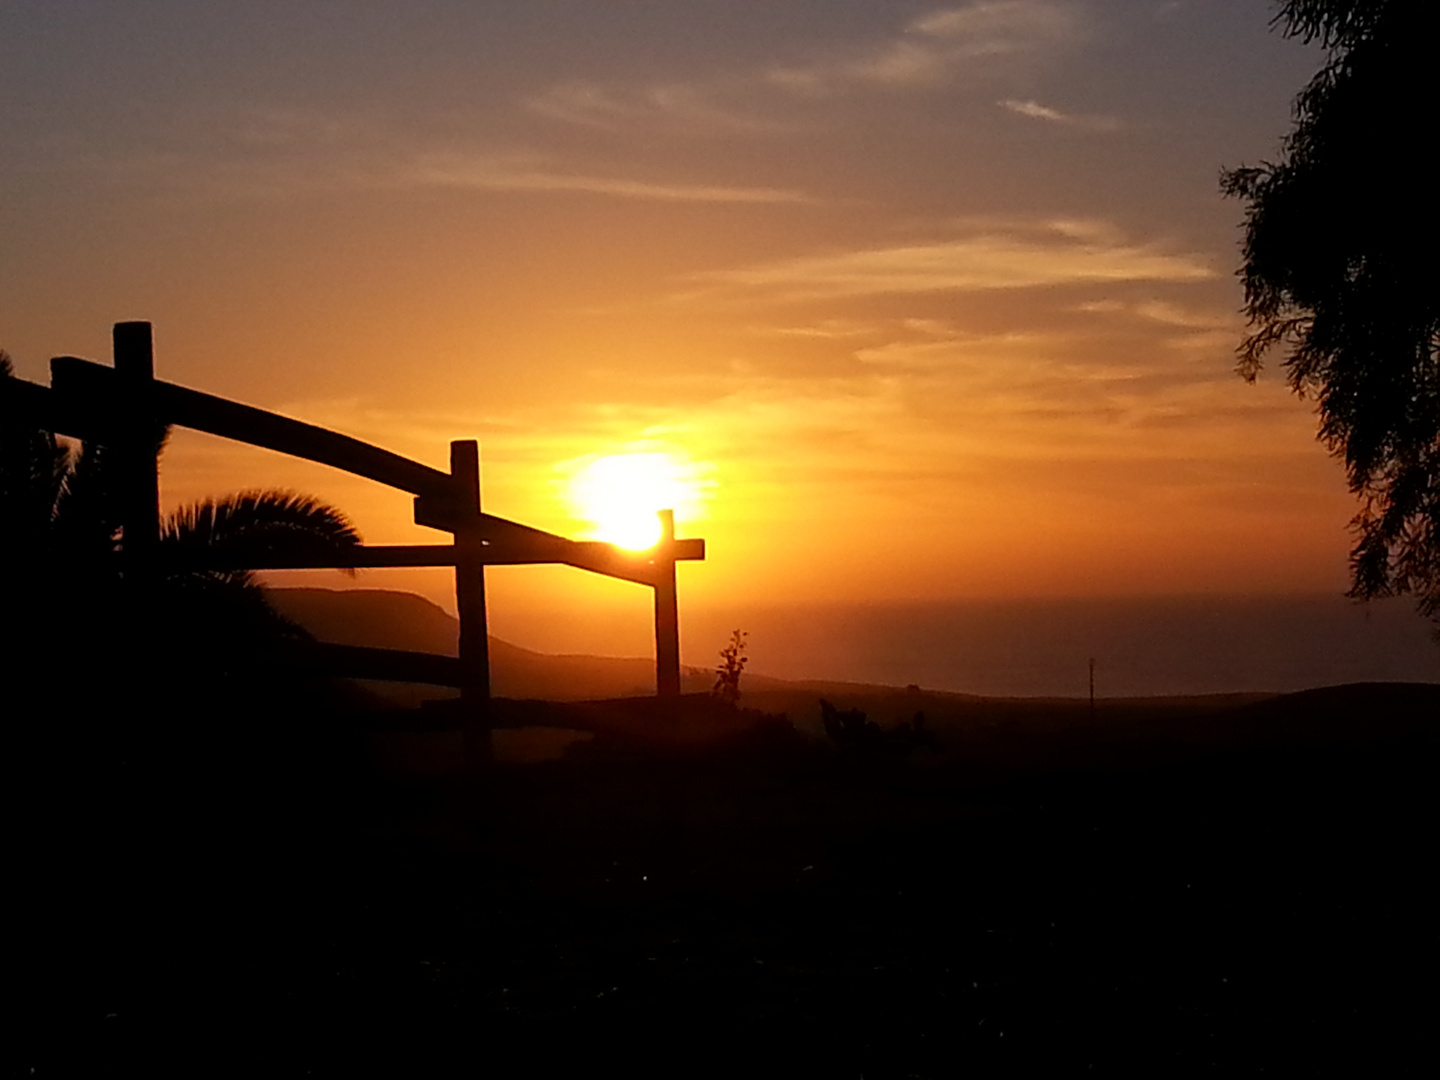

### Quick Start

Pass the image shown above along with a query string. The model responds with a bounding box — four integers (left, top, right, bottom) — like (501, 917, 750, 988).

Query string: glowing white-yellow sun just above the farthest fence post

(564, 452, 701, 552)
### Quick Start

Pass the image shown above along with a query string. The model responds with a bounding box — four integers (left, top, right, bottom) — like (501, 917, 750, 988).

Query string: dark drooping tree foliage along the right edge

(1221, 0, 1440, 621)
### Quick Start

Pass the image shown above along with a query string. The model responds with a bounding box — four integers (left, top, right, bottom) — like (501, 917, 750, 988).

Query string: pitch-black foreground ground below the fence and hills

(7, 687, 1440, 1077)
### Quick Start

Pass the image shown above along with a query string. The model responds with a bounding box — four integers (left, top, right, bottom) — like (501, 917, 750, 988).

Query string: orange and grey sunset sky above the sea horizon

(0, 0, 1355, 665)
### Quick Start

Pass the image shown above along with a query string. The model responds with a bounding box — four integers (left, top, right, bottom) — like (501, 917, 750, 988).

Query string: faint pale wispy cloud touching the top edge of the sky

(768, 0, 1080, 95)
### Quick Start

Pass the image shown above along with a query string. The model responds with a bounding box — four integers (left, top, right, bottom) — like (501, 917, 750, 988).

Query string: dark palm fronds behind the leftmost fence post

(0, 351, 360, 694)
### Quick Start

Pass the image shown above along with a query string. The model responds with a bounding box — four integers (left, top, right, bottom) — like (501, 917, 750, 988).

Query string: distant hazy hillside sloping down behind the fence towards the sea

(266, 589, 1440, 772)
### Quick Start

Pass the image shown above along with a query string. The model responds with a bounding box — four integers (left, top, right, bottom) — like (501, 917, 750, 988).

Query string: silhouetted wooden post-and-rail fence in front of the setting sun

(10, 323, 706, 766)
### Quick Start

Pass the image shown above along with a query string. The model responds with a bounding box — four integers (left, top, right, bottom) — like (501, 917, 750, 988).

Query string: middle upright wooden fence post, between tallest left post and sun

(451, 439, 492, 779)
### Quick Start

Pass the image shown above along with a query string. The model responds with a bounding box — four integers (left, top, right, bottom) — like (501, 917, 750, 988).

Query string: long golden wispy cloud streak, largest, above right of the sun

(685, 222, 1215, 301)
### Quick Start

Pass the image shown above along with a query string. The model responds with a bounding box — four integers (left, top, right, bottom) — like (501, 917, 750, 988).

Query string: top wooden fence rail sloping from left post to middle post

(50, 357, 452, 497)
